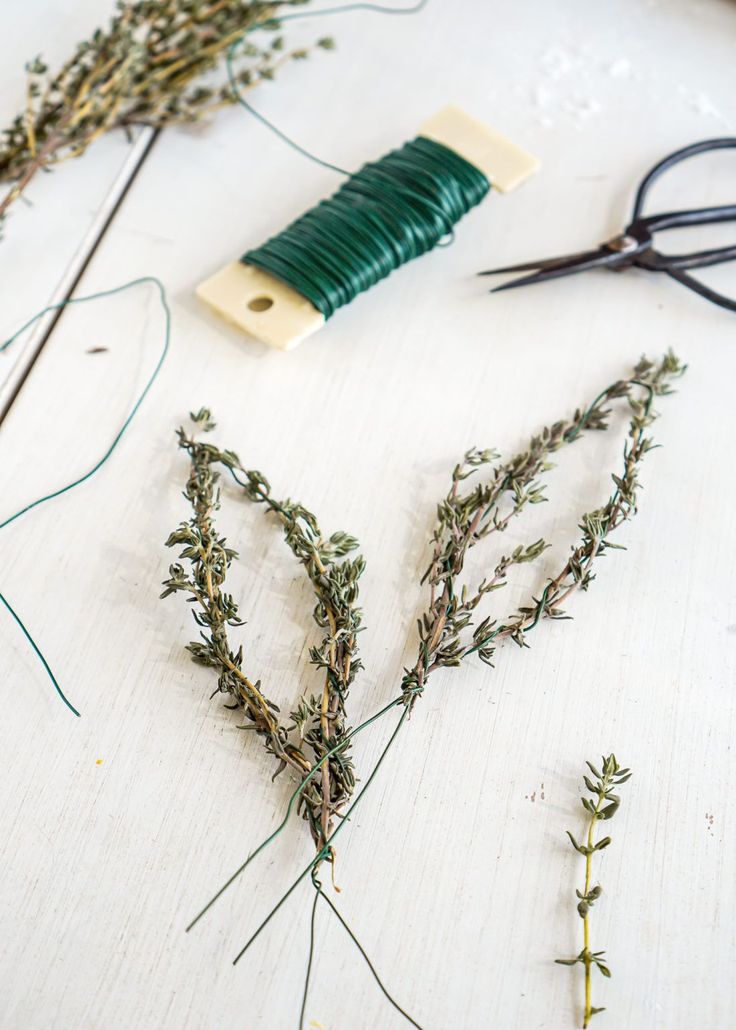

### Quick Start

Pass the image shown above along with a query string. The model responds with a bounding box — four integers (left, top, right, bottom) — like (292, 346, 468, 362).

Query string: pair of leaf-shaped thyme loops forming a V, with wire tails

(165, 352, 685, 1019)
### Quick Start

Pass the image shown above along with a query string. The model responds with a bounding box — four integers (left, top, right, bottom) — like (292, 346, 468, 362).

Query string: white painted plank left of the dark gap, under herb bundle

(0, 0, 144, 397)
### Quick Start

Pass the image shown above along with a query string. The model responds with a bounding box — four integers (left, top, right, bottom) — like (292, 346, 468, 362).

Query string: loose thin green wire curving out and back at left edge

(0, 275, 171, 716)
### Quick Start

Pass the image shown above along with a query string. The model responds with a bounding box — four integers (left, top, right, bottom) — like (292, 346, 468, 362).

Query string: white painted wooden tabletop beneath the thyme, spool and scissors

(0, 0, 736, 1030)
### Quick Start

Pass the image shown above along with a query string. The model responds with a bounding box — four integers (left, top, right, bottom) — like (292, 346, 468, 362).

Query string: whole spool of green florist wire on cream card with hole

(197, 107, 538, 350)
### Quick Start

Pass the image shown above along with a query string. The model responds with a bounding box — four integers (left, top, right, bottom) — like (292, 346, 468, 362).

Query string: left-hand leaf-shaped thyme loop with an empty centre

(162, 409, 365, 852)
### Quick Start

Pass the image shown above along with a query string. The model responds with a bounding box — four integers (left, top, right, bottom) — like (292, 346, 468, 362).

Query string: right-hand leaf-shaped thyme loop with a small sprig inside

(401, 352, 685, 706)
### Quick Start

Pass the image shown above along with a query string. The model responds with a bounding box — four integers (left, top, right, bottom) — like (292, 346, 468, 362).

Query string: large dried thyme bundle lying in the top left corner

(0, 0, 334, 232)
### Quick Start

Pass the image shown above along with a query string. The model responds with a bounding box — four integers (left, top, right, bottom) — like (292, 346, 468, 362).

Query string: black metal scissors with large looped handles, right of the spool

(479, 136, 736, 311)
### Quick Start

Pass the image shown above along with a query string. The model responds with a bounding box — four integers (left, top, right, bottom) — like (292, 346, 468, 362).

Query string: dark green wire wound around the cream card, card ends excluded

(241, 136, 491, 318)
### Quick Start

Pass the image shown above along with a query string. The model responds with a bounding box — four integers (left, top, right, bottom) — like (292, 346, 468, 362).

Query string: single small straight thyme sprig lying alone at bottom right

(555, 754, 631, 1030)
